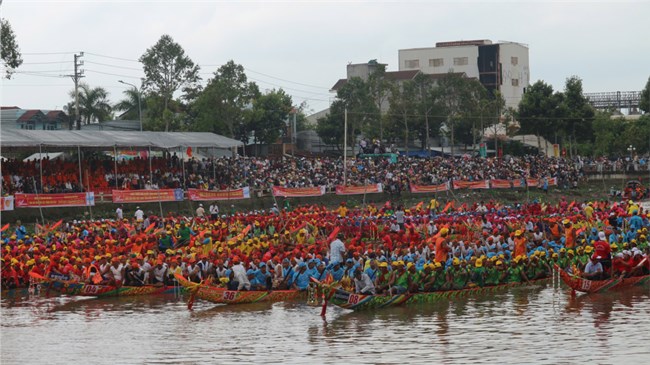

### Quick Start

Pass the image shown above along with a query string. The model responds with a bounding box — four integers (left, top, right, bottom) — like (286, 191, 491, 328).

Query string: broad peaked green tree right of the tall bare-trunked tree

(192, 60, 260, 138)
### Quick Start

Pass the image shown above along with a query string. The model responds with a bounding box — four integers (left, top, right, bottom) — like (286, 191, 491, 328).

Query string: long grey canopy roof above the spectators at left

(0, 129, 243, 149)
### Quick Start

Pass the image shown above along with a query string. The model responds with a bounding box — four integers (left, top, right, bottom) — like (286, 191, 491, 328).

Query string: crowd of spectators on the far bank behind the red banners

(2, 151, 587, 194)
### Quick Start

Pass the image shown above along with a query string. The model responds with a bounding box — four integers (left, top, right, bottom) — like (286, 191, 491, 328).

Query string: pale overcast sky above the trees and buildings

(0, 0, 650, 115)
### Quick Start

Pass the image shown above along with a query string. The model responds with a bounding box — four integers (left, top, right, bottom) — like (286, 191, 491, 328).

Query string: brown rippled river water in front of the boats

(0, 283, 650, 365)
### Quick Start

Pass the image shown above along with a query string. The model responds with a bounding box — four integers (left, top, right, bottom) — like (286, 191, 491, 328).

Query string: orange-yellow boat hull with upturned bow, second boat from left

(175, 274, 307, 309)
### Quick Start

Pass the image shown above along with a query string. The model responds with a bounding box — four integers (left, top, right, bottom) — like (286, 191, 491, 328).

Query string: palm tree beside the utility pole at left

(65, 83, 113, 127)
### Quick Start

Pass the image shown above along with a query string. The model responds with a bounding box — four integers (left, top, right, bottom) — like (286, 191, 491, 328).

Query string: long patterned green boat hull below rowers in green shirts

(319, 278, 551, 311)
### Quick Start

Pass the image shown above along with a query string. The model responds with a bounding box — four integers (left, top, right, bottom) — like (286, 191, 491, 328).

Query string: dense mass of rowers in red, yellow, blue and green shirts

(2, 195, 650, 292)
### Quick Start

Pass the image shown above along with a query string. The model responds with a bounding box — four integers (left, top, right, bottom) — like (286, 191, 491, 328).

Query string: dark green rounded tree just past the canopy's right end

(246, 89, 293, 154)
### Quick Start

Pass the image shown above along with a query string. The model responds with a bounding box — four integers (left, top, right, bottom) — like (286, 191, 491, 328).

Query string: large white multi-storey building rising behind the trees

(398, 40, 530, 108)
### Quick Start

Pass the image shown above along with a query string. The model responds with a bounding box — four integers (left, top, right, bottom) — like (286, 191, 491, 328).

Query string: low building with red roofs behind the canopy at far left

(0, 106, 70, 130)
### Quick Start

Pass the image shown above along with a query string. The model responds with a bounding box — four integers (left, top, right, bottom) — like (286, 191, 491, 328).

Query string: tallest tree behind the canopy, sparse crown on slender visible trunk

(140, 34, 200, 131)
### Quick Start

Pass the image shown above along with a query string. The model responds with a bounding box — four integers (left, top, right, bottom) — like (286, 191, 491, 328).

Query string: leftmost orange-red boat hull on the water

(29, 273, 184, 298)
